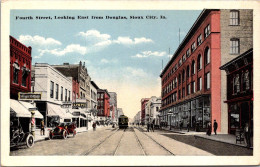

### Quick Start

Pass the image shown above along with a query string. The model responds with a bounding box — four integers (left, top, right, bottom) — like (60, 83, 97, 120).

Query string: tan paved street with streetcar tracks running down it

(10, 127, 212, 156)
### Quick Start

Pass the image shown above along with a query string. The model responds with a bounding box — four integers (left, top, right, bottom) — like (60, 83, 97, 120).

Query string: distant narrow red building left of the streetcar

(97, 89, 110, 118)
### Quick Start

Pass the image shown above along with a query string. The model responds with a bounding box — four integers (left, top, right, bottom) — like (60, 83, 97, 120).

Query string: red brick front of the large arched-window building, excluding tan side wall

(160, 10, 221, 130)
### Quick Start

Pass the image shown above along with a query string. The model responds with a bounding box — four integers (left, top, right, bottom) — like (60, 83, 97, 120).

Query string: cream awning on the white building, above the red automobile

(47, 103, 73, 119)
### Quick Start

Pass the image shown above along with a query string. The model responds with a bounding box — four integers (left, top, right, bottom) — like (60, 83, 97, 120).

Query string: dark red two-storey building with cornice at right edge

(220, 49, 253, 134)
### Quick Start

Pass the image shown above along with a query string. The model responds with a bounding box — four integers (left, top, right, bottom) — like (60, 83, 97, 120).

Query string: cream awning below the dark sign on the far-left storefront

(10, 99, 43, 118)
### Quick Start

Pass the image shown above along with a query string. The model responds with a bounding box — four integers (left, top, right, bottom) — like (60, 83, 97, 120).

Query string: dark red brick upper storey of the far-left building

(10, 36, 32, 99)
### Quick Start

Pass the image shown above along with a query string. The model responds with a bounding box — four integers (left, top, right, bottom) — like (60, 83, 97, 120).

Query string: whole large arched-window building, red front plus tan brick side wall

(160, 9, 252, 133)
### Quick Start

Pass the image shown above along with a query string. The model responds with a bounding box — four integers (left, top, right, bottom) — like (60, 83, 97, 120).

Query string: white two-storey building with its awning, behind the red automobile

(32, 63, 73, 126)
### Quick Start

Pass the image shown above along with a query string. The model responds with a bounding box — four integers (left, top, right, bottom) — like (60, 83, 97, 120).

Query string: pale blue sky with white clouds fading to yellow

(10, 10, 201, 118)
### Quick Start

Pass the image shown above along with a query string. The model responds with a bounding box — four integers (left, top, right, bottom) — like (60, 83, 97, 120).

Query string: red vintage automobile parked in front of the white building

(49, 122, 77, 139)
